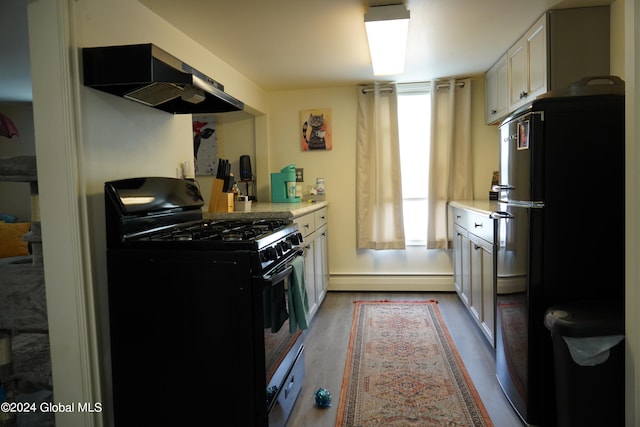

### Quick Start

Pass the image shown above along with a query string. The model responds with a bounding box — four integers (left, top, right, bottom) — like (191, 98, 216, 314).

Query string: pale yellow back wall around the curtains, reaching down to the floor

(269, 77, 498, 290)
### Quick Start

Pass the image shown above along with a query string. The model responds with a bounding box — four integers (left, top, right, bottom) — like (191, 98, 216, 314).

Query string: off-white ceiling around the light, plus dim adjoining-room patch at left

(0, 0, 612, 100)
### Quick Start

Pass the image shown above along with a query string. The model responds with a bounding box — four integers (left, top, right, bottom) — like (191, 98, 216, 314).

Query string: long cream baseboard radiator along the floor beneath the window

(329, 274, 455, 292)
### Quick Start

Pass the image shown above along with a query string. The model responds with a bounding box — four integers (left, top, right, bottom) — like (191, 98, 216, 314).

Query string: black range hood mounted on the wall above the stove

(82, 43, 244, 114)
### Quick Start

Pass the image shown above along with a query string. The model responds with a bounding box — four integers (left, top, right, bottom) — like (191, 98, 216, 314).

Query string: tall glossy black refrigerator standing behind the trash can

(494, 90, 625, 426)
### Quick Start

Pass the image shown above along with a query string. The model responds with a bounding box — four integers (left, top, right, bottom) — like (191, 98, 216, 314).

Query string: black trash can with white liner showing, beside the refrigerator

(544, 299, 624, 427)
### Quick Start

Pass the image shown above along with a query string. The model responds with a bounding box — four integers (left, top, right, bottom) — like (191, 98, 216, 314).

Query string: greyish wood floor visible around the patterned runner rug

(287, 292, 523, 427)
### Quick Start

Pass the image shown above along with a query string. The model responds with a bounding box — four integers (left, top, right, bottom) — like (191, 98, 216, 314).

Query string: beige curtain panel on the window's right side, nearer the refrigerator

(427, 79, 473, 249)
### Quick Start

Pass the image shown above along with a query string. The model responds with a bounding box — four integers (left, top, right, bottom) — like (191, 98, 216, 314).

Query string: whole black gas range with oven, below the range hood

(104, 177, 304, 426)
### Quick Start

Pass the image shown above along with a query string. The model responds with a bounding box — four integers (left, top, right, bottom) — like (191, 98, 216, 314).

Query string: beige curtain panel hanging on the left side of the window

(356, 84, 405, 249)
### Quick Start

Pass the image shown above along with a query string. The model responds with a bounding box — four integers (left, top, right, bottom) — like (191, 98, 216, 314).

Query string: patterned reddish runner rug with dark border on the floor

(336, 301, 493, 427)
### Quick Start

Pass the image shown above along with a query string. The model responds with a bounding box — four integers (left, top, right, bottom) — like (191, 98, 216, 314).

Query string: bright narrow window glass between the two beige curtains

(398, 84, 431, 246)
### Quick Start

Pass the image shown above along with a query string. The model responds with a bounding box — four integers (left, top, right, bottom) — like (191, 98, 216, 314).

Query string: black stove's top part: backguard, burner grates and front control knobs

(105, 177, 302, 273)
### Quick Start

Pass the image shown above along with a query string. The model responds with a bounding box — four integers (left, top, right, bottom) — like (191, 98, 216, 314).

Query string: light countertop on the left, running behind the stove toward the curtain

(202, 201, 329, 219)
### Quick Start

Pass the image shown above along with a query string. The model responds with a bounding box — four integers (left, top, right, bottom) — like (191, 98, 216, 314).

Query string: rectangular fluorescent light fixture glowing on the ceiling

(364, 4, 410, 76)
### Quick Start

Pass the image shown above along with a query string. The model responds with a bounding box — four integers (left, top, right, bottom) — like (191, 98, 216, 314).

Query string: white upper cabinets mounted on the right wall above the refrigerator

(485, 6, 609, 124)
